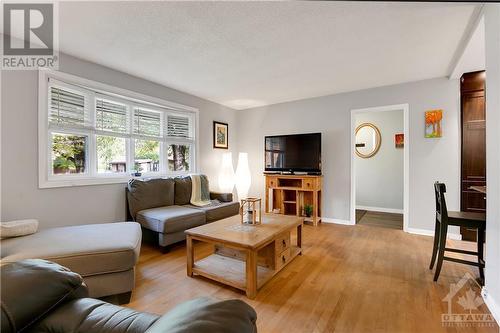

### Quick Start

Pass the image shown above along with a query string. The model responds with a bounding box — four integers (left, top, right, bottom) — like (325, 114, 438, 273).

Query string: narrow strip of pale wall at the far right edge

(485, 4, 500, 322)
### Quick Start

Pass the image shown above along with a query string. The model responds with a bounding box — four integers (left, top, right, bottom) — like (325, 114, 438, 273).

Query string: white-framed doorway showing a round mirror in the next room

(351, 104, 410, 231)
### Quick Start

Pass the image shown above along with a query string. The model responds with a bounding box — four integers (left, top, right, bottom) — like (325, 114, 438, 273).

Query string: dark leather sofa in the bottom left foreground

(1, 259, 257, 333)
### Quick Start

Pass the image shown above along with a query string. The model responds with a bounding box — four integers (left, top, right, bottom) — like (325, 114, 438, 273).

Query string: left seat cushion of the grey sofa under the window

(137, 205, 205, 234)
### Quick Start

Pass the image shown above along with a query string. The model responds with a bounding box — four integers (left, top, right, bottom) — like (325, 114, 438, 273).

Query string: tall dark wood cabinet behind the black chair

(460, 71, 486, 241)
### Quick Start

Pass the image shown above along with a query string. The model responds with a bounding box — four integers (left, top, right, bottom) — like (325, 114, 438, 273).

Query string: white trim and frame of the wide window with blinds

(38, 69, 200, 188)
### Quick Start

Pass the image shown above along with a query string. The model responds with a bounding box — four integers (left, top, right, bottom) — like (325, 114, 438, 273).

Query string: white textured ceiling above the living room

(52, 2, 475, 109)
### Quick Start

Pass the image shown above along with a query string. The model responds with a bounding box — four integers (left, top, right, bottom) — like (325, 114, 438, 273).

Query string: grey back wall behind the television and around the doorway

(238, 78, 460, 232)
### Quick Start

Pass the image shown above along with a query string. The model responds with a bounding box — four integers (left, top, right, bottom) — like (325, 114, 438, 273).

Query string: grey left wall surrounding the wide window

(1, 54, 237, 228)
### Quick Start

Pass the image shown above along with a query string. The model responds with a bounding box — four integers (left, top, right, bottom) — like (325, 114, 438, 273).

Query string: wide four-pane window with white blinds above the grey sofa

(39, 71, 197, 187)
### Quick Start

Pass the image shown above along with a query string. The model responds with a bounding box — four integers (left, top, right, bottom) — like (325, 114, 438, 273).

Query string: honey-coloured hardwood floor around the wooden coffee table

(128, 224, 498, 333)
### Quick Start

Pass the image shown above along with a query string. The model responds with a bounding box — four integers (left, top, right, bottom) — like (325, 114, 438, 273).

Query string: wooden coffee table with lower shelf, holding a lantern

(186, 214, 304, 299)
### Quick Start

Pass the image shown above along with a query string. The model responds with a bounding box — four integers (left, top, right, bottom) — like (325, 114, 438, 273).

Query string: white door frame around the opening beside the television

(350, 104, 410, 231)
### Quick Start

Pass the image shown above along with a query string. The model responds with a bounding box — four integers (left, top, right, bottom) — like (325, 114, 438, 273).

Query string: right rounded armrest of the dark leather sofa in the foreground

(145, 297, 257, 333)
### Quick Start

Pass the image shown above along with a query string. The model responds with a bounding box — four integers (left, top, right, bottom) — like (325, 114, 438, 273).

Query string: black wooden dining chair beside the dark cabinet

(429, 182, 486, 284)
